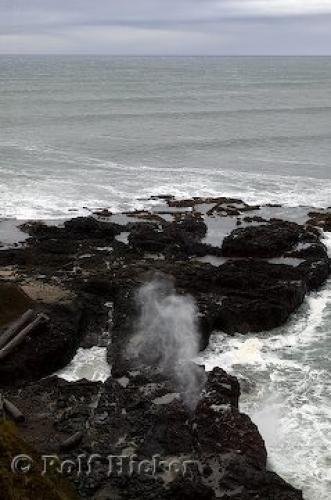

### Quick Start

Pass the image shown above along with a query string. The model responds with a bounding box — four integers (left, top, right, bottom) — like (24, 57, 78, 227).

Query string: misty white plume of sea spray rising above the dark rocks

(128, 276, 206, 409)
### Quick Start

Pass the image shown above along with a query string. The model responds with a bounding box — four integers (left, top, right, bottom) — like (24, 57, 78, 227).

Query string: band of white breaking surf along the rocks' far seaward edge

(0, 165, 331, 219)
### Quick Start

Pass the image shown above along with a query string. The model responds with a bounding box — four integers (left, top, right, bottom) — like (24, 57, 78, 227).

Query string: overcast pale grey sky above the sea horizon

(0, 0, 331, 55)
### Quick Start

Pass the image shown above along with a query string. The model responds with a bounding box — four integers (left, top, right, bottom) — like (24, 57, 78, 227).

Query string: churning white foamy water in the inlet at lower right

(200, 283, 331, 500)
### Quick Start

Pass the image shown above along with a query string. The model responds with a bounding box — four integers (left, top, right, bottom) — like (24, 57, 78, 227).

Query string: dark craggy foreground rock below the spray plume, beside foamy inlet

(3, 369, 302, 500)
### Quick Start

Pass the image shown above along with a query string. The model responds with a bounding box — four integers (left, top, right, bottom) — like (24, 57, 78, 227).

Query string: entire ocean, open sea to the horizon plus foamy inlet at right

(0, 56, 331, 500)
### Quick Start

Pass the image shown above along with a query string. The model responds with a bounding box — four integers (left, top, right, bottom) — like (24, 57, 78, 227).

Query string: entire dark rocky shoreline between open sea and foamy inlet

(0, 195, 331, 500)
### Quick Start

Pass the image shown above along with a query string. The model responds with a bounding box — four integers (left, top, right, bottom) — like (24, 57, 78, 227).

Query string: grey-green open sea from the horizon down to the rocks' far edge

(0, 56, 331, 218)
